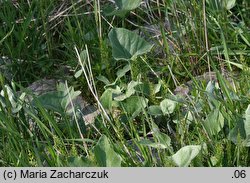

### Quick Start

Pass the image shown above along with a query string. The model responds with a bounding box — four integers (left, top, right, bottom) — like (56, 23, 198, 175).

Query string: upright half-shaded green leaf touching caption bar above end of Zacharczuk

(94, 135, 122, 167)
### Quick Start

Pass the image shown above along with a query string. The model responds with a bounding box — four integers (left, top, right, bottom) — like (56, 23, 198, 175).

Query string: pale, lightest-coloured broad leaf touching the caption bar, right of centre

(172, 145, 201, 167)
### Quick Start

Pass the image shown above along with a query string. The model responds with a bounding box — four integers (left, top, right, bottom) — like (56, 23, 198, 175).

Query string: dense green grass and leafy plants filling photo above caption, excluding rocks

(0, 0, 250, 167)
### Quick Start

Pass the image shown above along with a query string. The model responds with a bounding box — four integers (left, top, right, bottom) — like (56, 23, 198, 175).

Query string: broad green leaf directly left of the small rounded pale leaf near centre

(120, 96, 148, 118)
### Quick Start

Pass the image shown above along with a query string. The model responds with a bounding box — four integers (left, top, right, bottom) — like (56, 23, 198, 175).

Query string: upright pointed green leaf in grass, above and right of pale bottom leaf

(203, 108, 224, 137)
